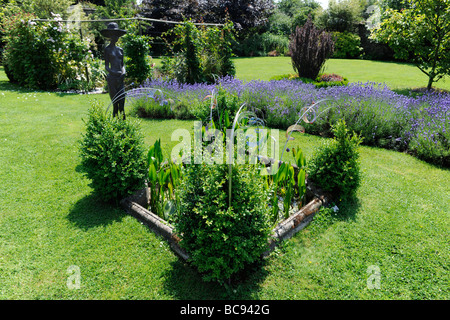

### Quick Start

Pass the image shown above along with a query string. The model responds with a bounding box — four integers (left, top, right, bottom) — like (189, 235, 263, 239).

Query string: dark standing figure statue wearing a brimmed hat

(100, 22, 126, 119)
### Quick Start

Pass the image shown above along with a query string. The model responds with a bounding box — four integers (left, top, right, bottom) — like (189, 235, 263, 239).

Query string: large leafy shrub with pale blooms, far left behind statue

(2, 13, 93, 90)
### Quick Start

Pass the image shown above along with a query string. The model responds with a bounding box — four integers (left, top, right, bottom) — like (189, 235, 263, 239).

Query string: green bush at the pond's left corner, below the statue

(79, 104, 146, 201)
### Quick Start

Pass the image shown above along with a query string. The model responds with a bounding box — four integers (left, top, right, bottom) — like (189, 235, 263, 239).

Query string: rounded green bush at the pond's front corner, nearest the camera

(175, 164, 270, 281)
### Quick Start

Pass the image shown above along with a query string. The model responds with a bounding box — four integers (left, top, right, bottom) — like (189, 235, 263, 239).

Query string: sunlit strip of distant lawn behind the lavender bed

(234, 57, 450, 90)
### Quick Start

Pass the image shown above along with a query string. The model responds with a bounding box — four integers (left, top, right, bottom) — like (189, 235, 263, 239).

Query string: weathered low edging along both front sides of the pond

(120, 176, 329, 261)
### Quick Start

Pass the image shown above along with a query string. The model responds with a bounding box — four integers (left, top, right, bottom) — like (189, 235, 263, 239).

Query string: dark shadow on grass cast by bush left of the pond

(67, 193, 126, 230)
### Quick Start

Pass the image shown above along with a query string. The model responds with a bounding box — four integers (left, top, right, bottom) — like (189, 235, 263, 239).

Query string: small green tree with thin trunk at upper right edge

(371, 0, 450, 90)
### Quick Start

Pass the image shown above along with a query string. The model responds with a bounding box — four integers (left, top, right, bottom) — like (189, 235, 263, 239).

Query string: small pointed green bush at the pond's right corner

(308, 120, 362, 201)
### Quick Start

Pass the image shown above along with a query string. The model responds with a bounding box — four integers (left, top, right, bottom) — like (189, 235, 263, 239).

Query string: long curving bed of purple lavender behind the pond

(129, 78, 450, 167)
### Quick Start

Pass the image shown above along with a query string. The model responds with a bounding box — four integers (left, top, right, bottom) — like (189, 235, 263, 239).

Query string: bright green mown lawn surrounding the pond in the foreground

(0, 65, 450, 299)
